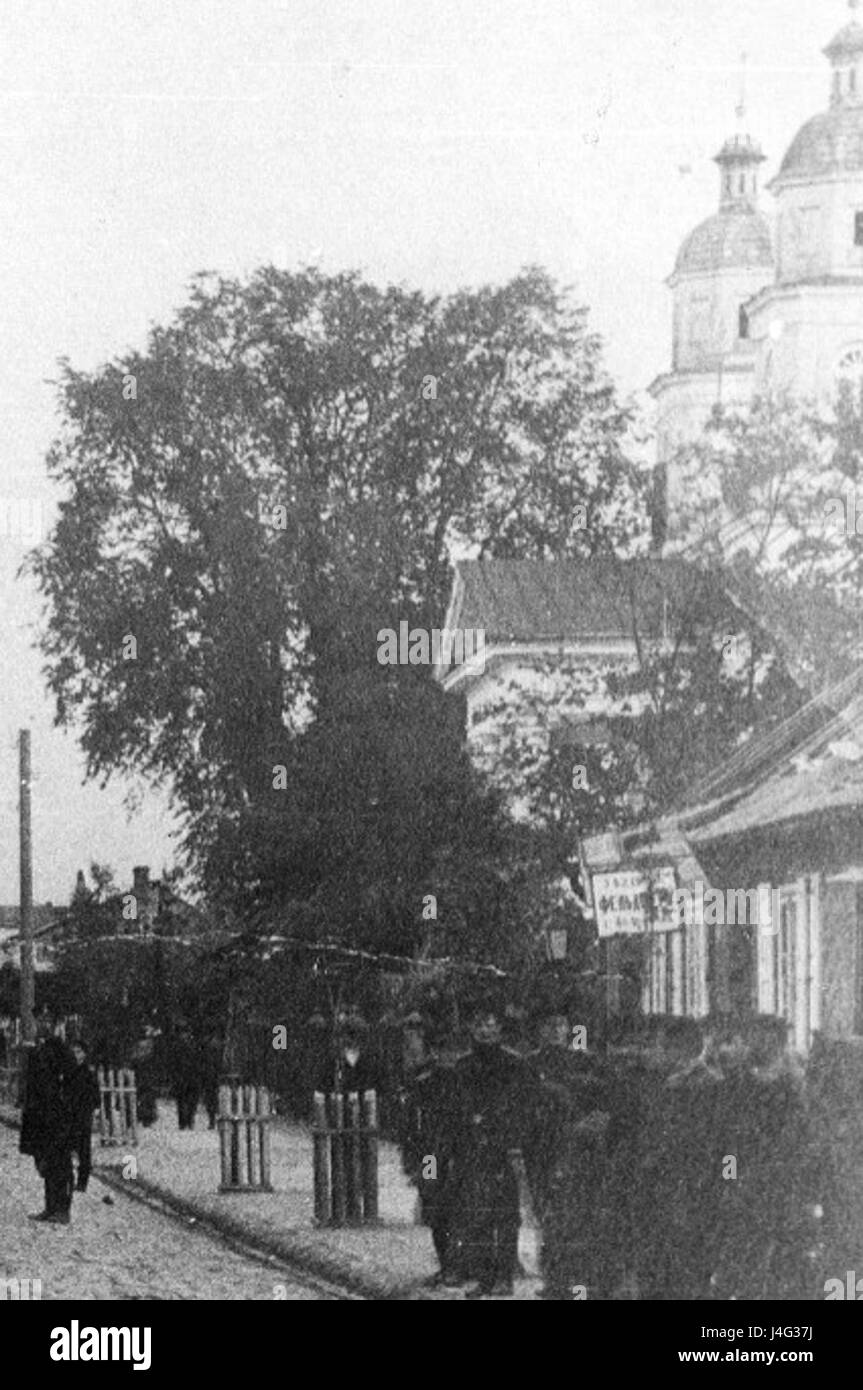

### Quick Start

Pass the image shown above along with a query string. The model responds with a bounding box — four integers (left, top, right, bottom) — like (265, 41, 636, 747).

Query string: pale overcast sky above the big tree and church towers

(0, 0, 848, 902)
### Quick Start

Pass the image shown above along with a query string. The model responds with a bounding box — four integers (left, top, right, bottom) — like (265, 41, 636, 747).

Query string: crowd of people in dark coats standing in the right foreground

(402, 1006, 830, 1300)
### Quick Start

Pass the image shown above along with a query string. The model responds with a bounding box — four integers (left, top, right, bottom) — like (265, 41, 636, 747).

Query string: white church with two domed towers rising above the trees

(649, 0, 863, 517)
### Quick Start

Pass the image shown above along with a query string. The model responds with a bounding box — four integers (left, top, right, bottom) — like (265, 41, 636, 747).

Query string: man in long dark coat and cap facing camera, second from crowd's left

(452, 1006, 527, 1298)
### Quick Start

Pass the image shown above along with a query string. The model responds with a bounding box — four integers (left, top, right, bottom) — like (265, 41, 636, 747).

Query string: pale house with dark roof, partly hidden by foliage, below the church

(435, 556, 752, 813)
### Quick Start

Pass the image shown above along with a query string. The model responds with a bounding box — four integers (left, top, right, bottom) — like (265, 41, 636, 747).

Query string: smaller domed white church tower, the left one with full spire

(649, 100, 774, 533)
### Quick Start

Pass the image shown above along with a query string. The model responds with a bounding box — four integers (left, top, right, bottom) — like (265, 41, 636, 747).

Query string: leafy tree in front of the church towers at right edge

(677, 385, 863, 689)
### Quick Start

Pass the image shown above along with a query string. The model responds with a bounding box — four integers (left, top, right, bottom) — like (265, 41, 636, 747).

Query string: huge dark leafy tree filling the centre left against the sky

(32, 268, 643, 919)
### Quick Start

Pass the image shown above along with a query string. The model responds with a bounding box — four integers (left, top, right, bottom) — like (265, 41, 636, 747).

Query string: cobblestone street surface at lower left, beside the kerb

(0, 1129, 343, 1300)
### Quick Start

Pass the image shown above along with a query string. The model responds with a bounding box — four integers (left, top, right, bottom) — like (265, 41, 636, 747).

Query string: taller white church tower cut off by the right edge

(749, 0, 863, 409)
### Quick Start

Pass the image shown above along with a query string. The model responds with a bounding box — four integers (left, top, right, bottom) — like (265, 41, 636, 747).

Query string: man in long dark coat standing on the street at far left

(18, 1038, 75, 1226)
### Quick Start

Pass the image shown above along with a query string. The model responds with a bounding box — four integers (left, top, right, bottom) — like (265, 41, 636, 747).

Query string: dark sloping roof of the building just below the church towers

(449, 556, 734, 645)
